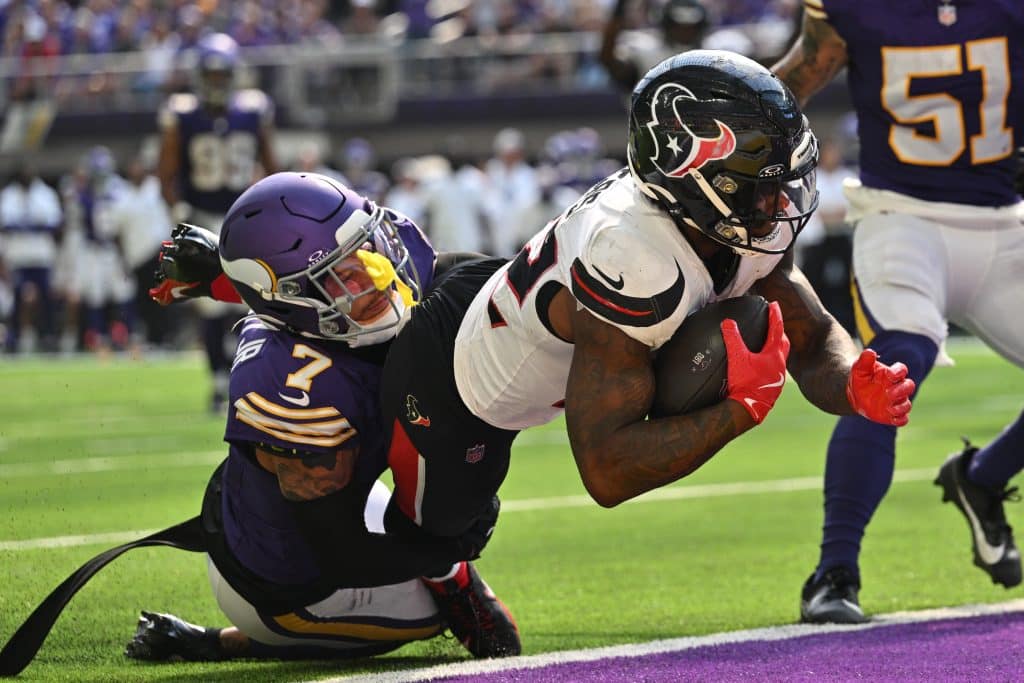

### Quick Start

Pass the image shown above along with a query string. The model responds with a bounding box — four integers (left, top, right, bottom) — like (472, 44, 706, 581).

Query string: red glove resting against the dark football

(722, 301, 790, 424)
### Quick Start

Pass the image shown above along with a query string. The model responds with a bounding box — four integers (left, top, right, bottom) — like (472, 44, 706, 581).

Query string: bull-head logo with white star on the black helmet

(647, 83, 736, 178)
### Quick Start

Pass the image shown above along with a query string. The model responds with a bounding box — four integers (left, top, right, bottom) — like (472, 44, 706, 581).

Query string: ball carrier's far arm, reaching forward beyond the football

(752, 250, 859, 415)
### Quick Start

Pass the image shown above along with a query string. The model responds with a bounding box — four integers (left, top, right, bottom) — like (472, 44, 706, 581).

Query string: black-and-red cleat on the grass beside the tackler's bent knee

(427, 562, 522, 659)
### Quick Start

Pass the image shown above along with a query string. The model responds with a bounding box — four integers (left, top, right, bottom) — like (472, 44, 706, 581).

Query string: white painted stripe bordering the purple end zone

(307, 599, 1024, 683)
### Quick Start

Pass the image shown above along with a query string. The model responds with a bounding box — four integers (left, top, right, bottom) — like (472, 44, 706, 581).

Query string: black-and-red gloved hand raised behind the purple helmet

(150, 223, 241, 306)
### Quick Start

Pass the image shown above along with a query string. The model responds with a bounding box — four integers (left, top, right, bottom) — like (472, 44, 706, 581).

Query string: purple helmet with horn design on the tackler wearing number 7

(220, 172, 434, 346)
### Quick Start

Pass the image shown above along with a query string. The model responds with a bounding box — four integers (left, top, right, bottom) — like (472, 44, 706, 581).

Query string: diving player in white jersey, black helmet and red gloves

(382, 50, 913, 561)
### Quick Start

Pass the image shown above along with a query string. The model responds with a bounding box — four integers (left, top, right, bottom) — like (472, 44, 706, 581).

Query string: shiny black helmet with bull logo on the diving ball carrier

(628, 50, 818, 255)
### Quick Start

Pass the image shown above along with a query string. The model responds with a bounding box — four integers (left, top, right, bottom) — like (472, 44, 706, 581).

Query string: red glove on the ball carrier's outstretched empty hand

(846, 348, 916, 427)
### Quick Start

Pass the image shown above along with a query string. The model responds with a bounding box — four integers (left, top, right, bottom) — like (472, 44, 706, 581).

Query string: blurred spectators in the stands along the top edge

(0, 0, 799, 100)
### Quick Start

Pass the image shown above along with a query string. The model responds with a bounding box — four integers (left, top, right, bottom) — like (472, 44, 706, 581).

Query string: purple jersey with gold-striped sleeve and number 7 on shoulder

(222, 318, 387, 585)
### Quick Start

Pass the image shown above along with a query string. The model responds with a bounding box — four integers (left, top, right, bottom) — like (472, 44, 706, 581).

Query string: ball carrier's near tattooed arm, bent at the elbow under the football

(565, 310, 755, 507)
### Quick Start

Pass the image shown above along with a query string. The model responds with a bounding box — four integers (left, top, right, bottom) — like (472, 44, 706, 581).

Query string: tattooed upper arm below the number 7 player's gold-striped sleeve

(256, 449, 358, 502)
